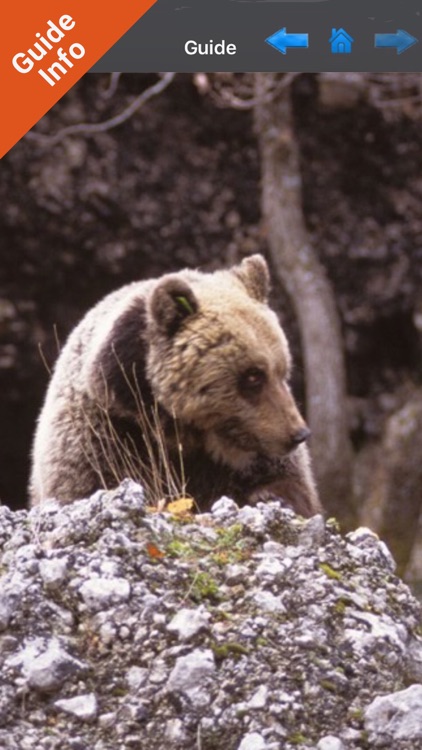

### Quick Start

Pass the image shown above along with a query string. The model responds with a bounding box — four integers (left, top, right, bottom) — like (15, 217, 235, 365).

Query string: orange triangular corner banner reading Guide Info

(0, 0, 156, 157)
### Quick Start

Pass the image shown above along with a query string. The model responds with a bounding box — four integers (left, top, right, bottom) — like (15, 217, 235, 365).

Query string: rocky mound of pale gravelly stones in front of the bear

(0, 480, 422, 750)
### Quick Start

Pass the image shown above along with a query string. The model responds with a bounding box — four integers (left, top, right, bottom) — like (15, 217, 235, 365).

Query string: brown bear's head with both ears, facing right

(147, 255, 309, 470)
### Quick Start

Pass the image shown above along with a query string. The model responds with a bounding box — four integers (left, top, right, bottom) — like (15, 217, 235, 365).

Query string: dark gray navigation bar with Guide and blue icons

(93, 0, 422, 72)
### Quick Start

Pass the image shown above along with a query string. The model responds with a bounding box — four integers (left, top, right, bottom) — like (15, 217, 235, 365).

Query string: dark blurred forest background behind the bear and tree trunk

(0, 74, 422, 576)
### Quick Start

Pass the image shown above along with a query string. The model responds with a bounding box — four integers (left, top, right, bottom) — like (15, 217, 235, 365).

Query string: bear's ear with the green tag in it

(150, 276, 198, 336)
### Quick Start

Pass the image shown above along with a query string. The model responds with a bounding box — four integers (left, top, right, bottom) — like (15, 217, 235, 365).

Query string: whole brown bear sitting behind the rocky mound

(30, 255, 320, 516)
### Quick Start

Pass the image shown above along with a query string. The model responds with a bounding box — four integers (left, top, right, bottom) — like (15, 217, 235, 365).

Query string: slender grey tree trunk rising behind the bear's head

(255, 73, 356, 528)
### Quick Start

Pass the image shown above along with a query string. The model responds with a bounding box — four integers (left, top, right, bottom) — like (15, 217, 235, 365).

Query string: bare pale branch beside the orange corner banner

(25, 73, 176, 146)
